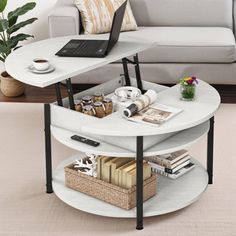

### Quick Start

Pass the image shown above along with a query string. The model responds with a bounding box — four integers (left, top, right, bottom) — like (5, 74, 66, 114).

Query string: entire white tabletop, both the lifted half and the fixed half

(5, 35, 220, 136)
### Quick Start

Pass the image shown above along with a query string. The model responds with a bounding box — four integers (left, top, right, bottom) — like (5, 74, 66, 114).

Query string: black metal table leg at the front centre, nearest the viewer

(136, 136, 143, 230)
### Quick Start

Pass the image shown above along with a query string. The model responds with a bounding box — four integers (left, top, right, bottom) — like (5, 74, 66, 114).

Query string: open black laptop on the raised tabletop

(56, 1, 127, 57)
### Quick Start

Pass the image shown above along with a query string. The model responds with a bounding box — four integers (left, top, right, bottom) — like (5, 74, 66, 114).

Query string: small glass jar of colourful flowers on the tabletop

(180, 76, 198, 101)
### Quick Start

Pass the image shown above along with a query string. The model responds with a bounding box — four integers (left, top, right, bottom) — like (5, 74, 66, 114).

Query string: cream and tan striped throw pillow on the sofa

(75, 0, 137, 34)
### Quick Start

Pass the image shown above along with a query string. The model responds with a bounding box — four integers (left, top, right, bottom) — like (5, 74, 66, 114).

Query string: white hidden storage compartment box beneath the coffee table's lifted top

(51, 77, 177, 152)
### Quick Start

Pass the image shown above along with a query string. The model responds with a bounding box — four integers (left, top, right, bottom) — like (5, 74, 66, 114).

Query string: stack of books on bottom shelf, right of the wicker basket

(145, 149, 195, 179)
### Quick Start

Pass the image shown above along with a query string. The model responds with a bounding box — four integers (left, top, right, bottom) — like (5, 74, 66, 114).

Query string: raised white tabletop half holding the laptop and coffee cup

(5, 34, 152, 88)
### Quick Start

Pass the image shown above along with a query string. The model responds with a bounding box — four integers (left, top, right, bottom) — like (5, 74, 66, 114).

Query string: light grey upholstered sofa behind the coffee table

(48, 0, 236, 84)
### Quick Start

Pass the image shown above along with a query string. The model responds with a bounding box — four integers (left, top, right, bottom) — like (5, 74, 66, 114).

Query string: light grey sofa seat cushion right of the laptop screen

(121, 27, 236, 63)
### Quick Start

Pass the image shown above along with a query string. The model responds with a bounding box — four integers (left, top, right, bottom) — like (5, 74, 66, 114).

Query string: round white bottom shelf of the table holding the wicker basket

(53, 154, 208, 218)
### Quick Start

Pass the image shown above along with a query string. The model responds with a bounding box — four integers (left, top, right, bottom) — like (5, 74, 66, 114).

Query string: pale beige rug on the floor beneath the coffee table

(0, 103, 236, 236)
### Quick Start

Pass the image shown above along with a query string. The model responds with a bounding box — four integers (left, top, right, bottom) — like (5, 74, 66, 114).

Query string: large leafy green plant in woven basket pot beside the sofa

(0, 0, 37, 97)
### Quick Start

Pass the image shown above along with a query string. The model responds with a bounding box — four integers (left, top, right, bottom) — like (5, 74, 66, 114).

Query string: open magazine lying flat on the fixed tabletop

(126, 103, 182, 126)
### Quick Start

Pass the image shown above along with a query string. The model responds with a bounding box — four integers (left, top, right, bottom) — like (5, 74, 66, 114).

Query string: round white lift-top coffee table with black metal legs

(6, 36, 220, 229)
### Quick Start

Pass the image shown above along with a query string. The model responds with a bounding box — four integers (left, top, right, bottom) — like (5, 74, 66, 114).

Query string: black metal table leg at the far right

(207, 116, 215, 184)
